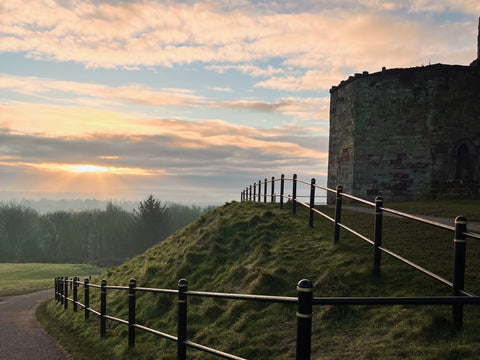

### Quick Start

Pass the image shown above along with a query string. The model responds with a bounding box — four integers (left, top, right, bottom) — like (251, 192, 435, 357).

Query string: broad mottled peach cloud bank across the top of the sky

(0, 0, 480, 76)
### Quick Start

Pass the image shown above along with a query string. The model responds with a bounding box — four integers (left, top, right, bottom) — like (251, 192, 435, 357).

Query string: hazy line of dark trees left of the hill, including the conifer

(0, 195, 214, 265)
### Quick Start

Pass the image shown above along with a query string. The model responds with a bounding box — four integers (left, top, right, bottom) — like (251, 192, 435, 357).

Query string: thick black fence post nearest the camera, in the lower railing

(296, 279, 313, 360)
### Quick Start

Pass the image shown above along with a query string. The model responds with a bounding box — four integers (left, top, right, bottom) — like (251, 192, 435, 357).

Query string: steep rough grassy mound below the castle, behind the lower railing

(43, 202, 480, 359)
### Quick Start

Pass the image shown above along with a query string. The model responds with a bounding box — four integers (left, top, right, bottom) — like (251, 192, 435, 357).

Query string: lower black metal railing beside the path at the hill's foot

(55, 276, 480, 360)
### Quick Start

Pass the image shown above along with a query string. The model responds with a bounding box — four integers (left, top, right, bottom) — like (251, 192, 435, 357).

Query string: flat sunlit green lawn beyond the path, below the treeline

(0, 263, 105, 296)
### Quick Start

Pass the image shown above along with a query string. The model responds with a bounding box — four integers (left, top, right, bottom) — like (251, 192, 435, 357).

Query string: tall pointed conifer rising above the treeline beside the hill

(133, 194, 168, 251)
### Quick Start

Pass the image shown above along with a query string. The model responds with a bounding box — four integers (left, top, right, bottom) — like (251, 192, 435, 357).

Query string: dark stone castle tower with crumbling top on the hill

(327, 19, 480, 201)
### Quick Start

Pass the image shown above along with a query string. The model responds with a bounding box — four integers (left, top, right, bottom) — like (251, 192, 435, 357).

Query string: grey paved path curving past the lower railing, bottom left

(0, 289, 68, 360)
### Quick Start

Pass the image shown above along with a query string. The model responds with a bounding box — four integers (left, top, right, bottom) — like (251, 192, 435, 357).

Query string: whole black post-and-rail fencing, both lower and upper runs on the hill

(55, 175, 480, 360)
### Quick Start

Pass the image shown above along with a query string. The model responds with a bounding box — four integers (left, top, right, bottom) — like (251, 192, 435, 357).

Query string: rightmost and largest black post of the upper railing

(452, 216, 467, 331)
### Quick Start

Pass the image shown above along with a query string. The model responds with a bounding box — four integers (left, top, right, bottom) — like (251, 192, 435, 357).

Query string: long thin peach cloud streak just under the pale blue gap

(0, 73, 327, 121)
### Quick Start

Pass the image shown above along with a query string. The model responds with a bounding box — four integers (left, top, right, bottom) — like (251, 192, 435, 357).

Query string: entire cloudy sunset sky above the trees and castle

(0, 0, 480, 205)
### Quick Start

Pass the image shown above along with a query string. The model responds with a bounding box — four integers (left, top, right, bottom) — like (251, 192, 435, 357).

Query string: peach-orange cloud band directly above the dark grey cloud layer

(0, 103, 324, 162)
